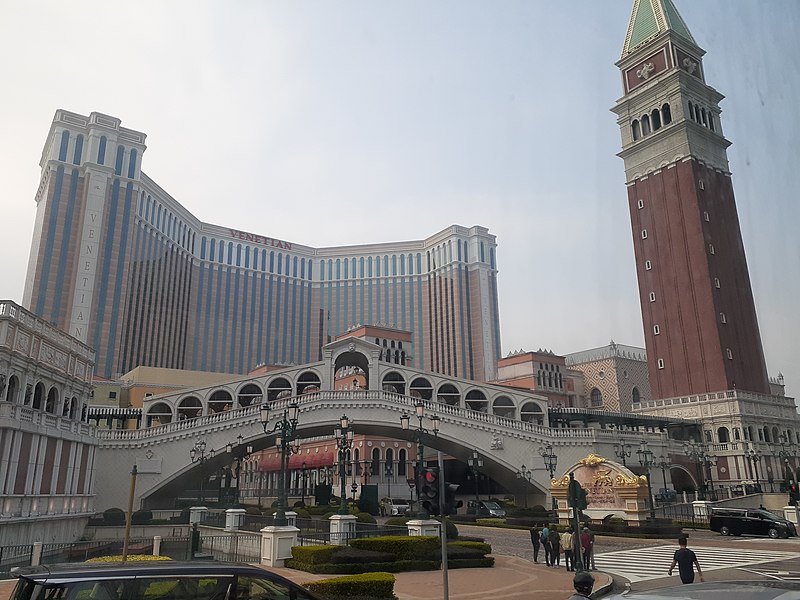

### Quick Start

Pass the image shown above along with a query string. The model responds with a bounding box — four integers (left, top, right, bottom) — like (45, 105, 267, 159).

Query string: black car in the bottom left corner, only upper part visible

(10, 561, 320, 600)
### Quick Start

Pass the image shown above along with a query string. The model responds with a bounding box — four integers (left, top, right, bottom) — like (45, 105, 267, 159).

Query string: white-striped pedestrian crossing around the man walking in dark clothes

(595, 545, 800, 583)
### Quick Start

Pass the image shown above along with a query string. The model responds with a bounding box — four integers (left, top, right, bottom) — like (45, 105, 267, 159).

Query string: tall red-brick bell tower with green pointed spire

(613, 0, 770, 398)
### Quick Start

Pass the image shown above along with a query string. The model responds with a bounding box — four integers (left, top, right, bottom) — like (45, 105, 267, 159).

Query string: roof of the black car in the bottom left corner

(12, 560, 276, 581)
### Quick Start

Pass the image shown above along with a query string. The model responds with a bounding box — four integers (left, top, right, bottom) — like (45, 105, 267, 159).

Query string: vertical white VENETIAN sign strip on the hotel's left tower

(69, 169, 107, 343)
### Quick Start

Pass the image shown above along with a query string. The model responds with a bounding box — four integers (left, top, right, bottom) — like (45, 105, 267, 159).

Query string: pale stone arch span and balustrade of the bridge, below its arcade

(95, 390, 668, 510)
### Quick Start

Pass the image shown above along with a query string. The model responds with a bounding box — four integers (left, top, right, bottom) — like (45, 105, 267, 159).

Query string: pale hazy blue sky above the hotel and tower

(0, 0, 800, 395)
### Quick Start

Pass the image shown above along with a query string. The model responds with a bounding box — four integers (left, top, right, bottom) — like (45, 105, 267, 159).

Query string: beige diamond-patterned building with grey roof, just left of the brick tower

(565, 340, 651, 412)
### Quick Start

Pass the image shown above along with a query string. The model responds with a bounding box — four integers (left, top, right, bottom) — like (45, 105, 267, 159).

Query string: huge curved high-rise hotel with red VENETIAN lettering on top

(23, 110, 500, 380)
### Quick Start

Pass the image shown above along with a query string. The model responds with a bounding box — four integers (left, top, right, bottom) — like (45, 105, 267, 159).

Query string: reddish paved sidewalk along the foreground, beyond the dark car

(0, 556, 612, 600)
